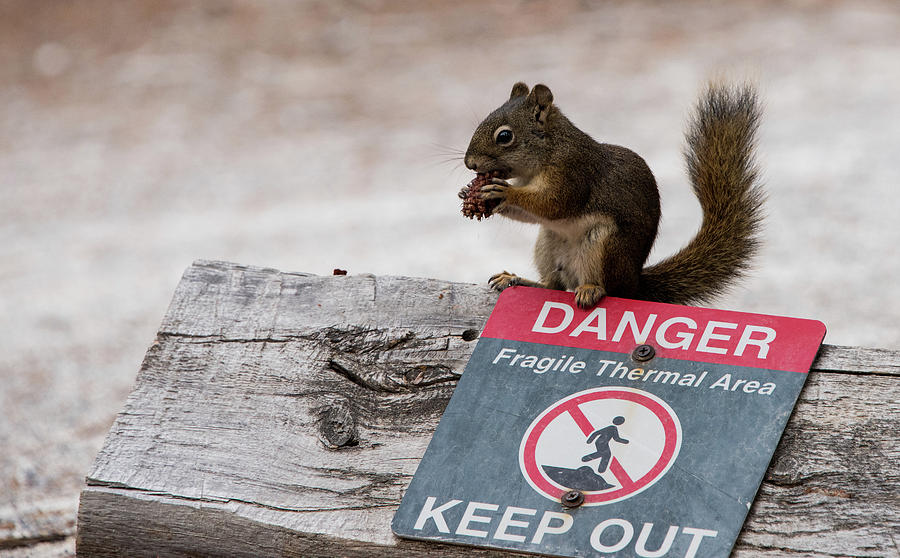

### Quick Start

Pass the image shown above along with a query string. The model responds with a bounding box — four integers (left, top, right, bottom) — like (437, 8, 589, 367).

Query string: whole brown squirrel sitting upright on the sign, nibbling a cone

(460, 82, 764, 309)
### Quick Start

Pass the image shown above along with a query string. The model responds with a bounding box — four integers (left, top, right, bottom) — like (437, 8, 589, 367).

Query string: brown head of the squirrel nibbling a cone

(465, 82, 558, 180)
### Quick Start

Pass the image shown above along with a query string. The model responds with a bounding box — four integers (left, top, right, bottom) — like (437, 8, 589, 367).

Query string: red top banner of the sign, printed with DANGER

(482, 287, 825, 373)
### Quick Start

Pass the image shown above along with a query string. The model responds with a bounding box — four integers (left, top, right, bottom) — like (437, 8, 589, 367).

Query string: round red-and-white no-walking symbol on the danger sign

(519, 387, 682, 506)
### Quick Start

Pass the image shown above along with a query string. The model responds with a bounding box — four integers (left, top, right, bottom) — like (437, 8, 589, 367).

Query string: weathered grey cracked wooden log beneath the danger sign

(77, 262, 900, 557)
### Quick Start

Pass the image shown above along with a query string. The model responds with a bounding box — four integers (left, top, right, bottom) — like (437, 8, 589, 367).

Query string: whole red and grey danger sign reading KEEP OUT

(393, 287, 825, 558)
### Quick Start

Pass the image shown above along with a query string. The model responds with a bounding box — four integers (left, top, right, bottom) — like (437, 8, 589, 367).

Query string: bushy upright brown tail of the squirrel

(640, 84, 764, 304)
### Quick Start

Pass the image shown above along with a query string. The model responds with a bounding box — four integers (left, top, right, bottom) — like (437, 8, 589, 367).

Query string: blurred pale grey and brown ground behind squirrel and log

(0, 0, 900, 556)
